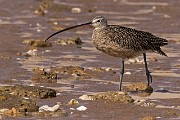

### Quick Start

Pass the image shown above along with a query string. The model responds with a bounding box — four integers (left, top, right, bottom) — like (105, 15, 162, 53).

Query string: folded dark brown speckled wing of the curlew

(108, 26, 160, 51)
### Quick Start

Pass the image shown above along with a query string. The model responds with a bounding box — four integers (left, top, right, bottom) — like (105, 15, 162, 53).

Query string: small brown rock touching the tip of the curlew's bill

(23, 39, 52, 47)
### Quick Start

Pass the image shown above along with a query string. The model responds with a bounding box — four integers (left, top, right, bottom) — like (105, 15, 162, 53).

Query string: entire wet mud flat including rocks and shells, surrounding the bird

(0, 0, 180, 120)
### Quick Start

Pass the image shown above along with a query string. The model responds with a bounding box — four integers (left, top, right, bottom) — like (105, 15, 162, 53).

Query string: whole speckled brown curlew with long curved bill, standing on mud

(45, 16, 168, 91)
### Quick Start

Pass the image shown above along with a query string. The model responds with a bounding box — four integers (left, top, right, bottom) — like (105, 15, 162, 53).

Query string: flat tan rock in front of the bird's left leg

(87, 91, 134, 103)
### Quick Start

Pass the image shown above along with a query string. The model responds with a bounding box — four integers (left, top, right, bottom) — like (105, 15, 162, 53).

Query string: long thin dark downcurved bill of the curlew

(45, 22, 92, 42)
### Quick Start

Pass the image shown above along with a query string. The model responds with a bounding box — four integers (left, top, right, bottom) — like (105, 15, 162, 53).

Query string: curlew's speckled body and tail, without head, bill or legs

(92, 25, 168, 58)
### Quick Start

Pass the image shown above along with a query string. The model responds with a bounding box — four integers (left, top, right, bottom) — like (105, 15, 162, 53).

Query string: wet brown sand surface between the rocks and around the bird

(0, 0, 180, 120)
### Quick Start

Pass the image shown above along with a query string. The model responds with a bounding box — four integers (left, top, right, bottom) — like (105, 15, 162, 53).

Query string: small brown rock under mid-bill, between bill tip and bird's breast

(57, 37, 82, 45)
